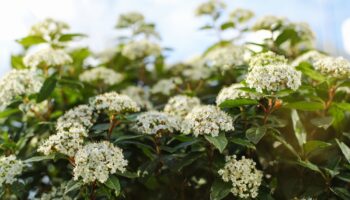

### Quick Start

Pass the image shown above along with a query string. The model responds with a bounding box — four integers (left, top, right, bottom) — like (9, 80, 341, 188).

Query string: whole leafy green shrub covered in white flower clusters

(0, 0, 350, 200)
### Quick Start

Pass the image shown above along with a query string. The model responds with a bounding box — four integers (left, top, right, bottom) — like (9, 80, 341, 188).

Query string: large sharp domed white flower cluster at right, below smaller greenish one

(246, 64, 301, 93)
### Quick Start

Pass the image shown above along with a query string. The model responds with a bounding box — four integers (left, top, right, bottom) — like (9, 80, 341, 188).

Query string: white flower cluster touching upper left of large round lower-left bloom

(38, 122, 88, 157)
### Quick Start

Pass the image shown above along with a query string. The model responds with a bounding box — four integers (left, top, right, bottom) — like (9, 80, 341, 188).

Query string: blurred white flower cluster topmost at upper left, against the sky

(29, 18, 69, 40)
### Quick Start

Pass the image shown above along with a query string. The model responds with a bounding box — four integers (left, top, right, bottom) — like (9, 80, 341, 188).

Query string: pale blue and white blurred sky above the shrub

(0, 0, 350, 76)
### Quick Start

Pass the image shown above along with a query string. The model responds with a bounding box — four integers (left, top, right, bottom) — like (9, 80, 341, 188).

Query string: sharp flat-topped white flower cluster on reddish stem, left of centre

(90, 92, 140, 115)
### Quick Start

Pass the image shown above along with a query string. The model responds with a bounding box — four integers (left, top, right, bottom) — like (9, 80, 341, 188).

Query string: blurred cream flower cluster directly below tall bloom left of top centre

(122, 39, 162, 60)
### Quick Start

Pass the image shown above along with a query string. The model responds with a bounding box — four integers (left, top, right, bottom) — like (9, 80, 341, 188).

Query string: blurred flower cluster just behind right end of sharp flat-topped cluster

(120, 86, 153, 110)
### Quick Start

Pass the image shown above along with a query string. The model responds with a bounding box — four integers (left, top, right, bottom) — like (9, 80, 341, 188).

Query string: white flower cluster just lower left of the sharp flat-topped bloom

(56, 105, 95, 131)
